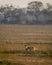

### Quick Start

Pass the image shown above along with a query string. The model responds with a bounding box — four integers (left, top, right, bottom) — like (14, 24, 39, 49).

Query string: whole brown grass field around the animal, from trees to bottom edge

(0, 25, 52, 65)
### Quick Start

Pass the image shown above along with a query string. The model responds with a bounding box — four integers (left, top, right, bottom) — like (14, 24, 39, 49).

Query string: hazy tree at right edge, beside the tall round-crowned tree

(42, 3, 52, 24)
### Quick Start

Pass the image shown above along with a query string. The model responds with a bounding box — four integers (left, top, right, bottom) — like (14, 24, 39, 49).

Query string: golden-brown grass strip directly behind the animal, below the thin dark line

(0, 42, 52, 51)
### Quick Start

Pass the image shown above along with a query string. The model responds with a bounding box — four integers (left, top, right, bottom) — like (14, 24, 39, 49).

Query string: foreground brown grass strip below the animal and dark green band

(0, 54, 52, 65)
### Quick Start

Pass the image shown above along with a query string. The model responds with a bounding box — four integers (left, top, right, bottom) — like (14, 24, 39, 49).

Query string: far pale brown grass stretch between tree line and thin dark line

(0, 25, 52, 43)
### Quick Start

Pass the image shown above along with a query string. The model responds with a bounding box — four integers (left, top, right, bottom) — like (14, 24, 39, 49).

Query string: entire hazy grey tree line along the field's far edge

(0, 1, 52, 25)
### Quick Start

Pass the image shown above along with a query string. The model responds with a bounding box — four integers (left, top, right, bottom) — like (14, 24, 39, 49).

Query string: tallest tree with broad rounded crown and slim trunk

(28, 1, 43, 22)
